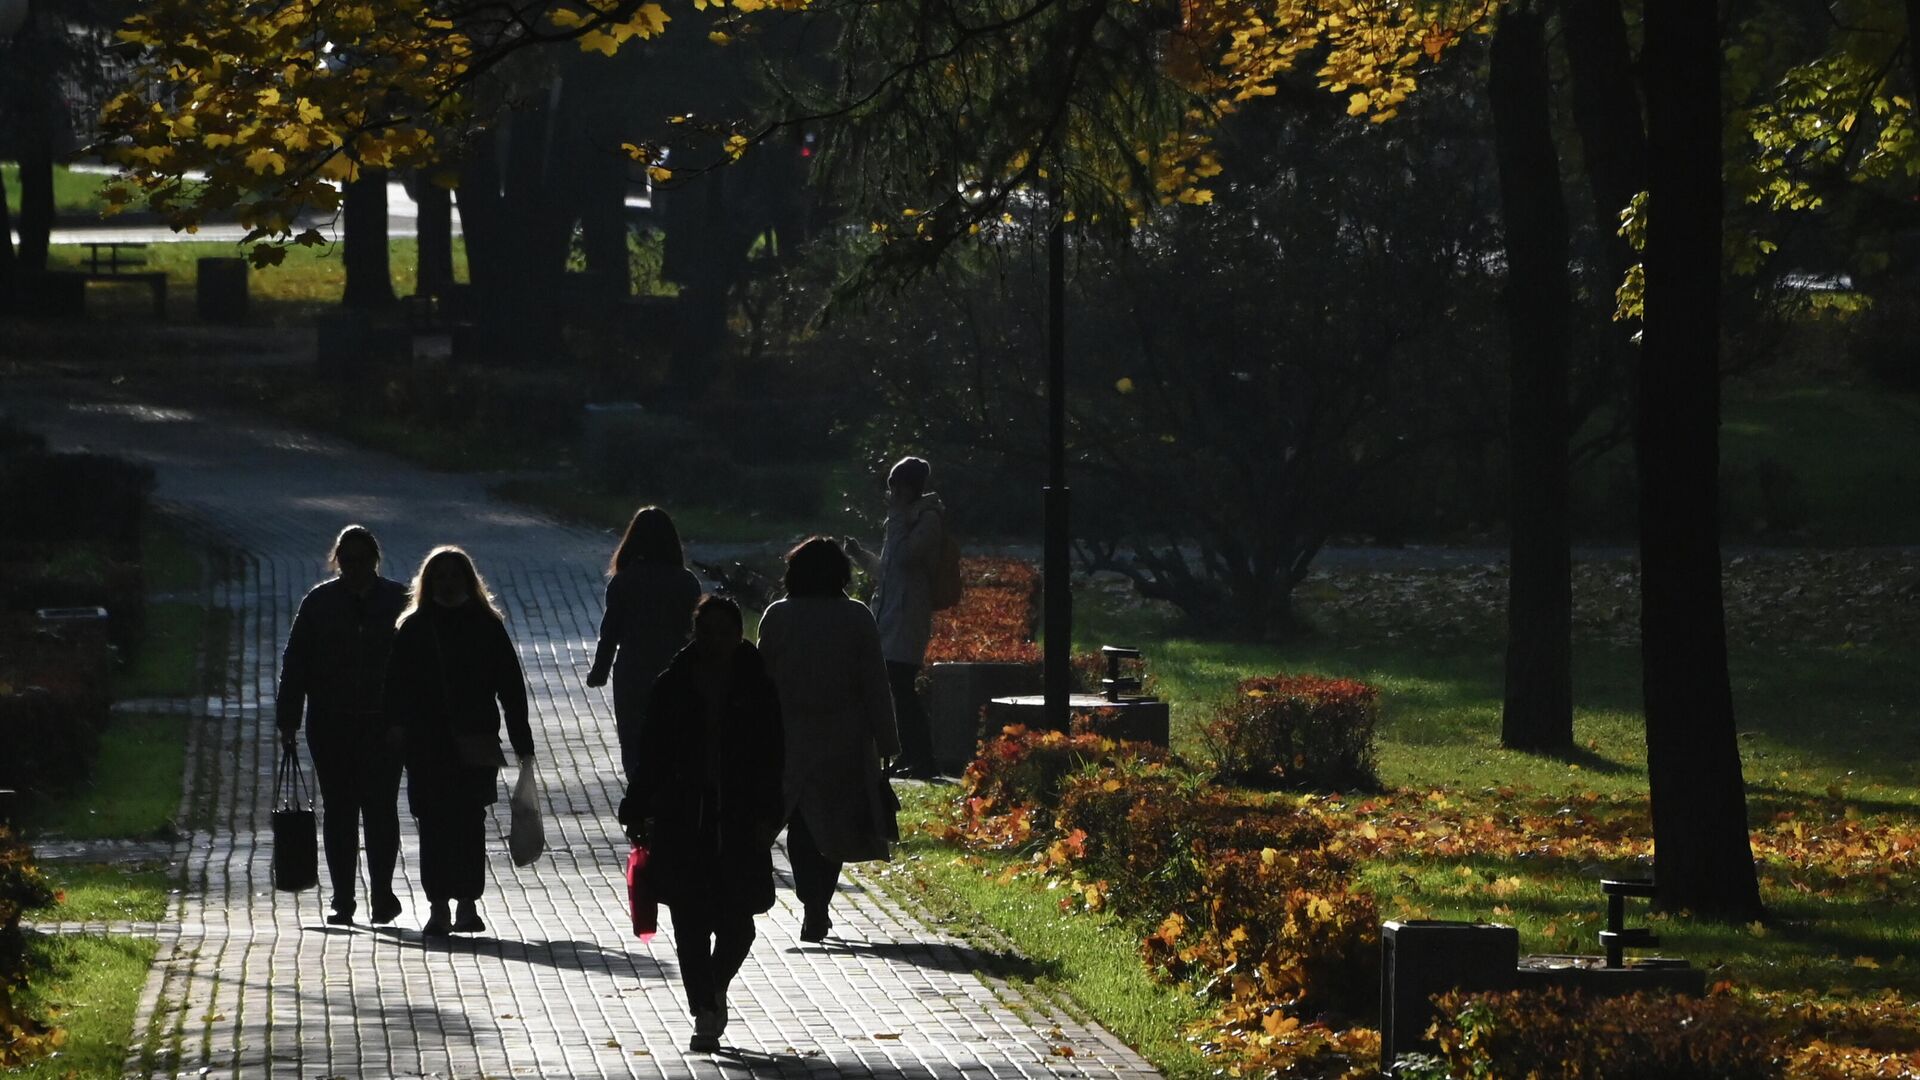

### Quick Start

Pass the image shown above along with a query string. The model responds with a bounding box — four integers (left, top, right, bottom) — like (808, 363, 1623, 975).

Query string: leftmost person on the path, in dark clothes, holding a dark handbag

(275, 525, 407, 926)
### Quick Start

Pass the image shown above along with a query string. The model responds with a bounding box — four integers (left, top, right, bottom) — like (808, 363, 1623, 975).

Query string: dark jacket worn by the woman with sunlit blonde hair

(386, 600, 534, 817)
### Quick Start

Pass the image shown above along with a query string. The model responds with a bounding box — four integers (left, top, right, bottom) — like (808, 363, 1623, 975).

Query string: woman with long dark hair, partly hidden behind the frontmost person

(588, 505, 701, 784)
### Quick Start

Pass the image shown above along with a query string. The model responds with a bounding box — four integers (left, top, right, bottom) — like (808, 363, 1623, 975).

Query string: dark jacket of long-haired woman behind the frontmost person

(593, 563, 701, 780)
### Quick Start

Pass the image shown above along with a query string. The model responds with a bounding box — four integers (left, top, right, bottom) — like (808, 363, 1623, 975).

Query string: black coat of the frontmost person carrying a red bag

(628, 642, 785, 915)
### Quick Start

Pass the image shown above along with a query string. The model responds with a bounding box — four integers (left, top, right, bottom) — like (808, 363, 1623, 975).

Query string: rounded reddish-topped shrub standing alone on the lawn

(1206, 675, 1380, 790)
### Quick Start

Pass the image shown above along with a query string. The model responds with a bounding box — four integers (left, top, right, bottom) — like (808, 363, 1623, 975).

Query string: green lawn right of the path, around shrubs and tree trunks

(895, 588, 1920, 1076)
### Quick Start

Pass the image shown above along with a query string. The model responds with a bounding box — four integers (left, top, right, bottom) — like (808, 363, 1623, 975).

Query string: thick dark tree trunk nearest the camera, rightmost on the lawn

(1634, 0, 1763, 920)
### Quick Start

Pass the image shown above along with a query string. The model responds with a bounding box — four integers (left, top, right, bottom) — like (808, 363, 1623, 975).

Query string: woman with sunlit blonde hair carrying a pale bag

(386, 548, 534, 938)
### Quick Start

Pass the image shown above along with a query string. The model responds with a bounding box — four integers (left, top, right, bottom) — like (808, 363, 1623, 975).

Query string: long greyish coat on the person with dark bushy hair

(760, 596, 900, 863)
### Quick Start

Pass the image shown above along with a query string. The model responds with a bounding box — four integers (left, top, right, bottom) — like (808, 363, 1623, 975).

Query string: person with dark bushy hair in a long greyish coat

(760, 536, 900, 942)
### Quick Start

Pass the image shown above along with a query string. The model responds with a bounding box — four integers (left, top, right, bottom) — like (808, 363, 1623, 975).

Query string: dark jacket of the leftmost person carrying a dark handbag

(275, 578, 407, 742)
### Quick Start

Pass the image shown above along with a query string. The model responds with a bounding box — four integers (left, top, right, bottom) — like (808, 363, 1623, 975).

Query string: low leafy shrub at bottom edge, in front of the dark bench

(1434, 990, 1782, 1080)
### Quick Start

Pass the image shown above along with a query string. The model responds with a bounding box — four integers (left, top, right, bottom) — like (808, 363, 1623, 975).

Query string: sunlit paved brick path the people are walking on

(10, 390, 1152, 1080)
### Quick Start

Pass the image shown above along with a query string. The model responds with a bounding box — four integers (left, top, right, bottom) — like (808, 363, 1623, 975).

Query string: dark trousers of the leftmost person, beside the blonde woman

(307, 728, 399, 915)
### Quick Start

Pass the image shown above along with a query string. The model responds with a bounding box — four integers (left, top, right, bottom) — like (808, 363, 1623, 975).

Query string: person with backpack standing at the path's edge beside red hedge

(847, 457, 960, 780)
